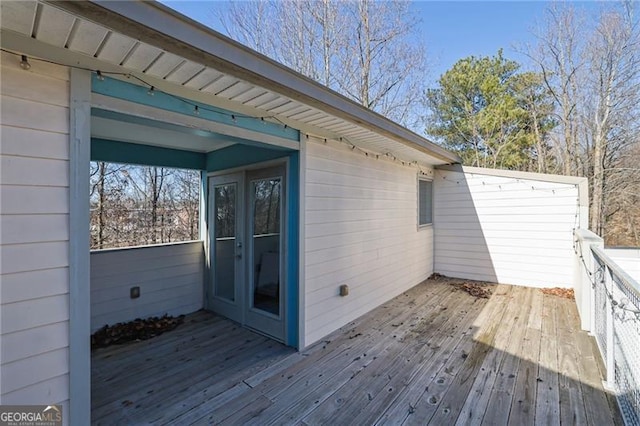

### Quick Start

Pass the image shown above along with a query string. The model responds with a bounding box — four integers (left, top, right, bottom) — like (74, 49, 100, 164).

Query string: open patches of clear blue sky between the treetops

(161, 0, 599, 85)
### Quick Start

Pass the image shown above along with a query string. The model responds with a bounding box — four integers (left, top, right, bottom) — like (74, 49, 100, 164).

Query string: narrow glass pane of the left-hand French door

(214, 183, 237, 301)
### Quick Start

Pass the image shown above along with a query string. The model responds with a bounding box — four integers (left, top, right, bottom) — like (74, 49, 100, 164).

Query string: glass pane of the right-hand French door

(251, 177, 282, 315)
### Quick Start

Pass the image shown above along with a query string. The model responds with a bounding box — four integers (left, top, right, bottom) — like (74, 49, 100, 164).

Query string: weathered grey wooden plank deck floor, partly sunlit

(92, 279, 621, 425)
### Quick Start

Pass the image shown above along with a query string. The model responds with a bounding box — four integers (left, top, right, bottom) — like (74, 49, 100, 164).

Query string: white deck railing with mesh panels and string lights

(576, 231, 640, 426)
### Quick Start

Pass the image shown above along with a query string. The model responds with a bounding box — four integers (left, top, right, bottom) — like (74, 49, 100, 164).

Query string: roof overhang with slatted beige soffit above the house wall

(0, 1, 459, 166)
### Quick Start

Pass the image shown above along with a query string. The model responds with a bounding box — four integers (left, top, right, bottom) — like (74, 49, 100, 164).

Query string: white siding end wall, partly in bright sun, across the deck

(434, 168, 586, 287)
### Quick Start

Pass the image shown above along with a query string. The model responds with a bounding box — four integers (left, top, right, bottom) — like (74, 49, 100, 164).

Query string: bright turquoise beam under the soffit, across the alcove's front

(91, 74, 300, 142)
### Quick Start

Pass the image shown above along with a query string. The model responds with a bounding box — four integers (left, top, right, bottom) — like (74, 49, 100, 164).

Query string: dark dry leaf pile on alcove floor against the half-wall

(91, 315, 184, 349)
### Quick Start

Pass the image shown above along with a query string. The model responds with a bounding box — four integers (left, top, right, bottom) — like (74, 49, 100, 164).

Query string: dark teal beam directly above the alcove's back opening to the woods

(91, 138, 207, 170)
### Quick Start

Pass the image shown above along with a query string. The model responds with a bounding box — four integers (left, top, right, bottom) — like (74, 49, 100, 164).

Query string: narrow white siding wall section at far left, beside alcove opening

(0, 52, 69, 412)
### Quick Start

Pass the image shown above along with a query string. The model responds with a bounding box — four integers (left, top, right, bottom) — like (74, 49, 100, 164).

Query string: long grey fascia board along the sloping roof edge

(45, 0, 461, 163)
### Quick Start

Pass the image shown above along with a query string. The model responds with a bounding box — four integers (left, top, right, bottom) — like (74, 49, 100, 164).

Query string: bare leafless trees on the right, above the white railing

(527, 2, 640, 243)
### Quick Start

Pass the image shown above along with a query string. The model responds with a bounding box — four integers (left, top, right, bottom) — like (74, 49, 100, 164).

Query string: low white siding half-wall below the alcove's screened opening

(91, 241, 204, 332)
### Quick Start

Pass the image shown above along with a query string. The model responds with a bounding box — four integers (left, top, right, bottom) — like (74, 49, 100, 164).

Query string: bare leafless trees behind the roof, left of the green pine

(216, 0, 427, 128)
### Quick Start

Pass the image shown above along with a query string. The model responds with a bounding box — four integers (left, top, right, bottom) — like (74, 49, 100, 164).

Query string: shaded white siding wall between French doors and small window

(304, 139, 433, 345)
